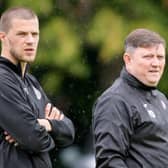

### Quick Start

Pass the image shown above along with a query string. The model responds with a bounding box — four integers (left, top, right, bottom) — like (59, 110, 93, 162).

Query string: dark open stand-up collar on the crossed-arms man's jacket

(0, 56, 29, 78)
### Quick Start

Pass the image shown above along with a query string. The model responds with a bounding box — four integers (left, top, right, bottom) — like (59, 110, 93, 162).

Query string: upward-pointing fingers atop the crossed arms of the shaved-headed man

(45, 103, 64, 120)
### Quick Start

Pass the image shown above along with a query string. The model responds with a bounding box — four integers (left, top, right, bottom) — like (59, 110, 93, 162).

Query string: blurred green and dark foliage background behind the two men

(0, 0, 168, 168)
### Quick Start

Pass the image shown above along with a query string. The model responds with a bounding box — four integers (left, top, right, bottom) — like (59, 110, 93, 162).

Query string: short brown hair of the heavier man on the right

(125, 28, 166, 50)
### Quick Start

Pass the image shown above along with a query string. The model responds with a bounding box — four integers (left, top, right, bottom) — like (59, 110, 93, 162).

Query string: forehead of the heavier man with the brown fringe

(135, 44, 165, 55)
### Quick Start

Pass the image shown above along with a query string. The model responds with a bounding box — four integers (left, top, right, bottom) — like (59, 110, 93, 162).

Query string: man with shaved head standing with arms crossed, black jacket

(0, 7, 74, 168)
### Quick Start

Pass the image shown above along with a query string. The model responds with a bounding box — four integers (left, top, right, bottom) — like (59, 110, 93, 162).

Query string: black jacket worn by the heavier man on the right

(93, 68, 168, 168)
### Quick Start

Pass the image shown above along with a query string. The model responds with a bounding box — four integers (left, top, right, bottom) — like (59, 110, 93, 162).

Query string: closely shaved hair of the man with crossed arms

(0, 7, 38, 32)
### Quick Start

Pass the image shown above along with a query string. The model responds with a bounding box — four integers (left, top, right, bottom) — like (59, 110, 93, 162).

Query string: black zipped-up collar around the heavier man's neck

(120, 67, 156, 90)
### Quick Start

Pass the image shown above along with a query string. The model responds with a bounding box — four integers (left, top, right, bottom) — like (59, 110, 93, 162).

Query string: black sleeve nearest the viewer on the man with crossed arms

(0, 76, 55, 153)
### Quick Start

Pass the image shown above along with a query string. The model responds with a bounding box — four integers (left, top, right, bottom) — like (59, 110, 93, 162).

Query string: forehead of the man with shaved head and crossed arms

(11, 18, 39, 32)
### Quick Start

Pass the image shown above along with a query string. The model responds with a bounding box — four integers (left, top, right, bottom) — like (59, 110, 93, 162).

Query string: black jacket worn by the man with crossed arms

(0, 57, 74, 168)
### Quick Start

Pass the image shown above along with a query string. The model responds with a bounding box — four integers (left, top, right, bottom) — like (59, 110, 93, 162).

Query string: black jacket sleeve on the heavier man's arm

(93, 95, 131, 168)
